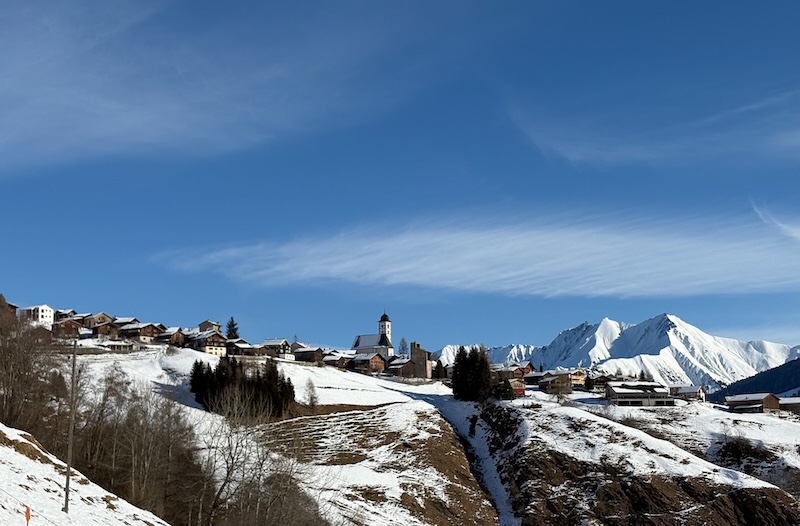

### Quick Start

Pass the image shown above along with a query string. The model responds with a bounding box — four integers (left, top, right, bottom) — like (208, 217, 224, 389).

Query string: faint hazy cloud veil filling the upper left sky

(0, 0, 450, 172)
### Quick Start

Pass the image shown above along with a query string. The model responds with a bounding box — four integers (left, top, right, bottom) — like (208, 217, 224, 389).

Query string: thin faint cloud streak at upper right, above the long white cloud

(508, 90, 800, 165)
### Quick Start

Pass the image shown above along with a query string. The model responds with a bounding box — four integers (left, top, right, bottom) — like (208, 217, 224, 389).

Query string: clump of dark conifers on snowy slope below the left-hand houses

(189, 357, 295, 423)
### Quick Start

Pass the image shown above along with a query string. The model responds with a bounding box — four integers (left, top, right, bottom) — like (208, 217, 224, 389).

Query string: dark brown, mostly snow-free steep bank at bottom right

(480, 405, 800, 526)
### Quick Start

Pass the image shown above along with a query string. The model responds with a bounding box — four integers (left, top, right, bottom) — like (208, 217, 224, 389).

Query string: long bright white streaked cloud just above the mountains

(155, 210, 800, 297)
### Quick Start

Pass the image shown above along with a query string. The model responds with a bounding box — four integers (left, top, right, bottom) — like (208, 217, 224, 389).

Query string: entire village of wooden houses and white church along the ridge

(0, 295, 800, 414)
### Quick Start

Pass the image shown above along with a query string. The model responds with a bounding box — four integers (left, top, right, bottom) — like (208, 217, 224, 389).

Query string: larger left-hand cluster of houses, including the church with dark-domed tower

(9, 304, 432, 378)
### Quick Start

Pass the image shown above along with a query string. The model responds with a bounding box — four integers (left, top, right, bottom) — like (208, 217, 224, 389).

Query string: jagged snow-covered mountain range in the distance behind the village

(433, 314, 800, 392)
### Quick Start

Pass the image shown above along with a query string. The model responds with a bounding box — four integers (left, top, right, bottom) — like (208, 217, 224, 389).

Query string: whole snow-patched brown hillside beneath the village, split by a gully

(67, 348, 800, 526)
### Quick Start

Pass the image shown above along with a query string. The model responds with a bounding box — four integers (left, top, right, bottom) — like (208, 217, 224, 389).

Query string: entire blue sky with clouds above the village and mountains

(0, 1, 800, 350)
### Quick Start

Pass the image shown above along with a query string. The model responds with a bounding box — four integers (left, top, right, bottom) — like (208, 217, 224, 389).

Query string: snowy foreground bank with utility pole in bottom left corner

(0, 424, 167, 526)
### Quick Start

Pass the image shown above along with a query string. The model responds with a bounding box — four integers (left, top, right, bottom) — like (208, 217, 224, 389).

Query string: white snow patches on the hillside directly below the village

(61, 347, 800, 526)
